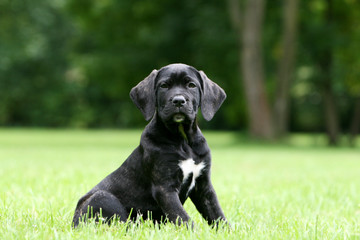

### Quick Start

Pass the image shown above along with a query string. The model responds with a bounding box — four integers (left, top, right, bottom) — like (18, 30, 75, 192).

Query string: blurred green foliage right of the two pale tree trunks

(291, 0, 360, 131)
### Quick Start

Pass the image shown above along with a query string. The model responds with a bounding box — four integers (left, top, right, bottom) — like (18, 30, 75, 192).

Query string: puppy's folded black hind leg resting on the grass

(73, 190, 128, 227)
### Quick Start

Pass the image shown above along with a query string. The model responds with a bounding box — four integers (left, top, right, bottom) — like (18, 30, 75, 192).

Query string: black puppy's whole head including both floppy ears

(130, 64, 226, 123)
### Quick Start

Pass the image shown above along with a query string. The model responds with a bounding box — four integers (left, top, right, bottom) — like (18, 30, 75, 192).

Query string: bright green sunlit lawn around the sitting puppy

(0, 129, 360, 240)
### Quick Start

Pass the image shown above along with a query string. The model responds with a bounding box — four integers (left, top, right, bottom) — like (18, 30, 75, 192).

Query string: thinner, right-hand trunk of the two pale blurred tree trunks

(274, 0, 298, 137)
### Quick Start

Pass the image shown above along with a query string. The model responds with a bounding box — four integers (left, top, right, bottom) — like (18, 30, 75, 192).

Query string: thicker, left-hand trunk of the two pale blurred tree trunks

(240, 0, 274, 139)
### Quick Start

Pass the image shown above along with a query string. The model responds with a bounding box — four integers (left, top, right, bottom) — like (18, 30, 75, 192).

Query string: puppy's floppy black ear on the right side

(199, 71, 226, 121)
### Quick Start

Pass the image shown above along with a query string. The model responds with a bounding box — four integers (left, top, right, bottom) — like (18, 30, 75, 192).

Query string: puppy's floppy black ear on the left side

(130, 69, 158, 121)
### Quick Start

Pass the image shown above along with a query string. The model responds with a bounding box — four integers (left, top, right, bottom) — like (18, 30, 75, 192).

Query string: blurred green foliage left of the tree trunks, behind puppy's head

(0, 0, 242, 128)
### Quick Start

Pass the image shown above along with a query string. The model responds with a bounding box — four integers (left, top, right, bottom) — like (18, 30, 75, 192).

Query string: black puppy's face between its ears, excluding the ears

(155, 65, 201, 123)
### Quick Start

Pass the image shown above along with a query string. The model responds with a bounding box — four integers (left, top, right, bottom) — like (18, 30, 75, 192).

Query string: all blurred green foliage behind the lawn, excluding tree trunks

(0, 0, 360, 131)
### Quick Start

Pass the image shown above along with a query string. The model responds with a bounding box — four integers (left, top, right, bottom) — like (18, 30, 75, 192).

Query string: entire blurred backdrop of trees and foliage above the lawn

(0, 0, 360, 145)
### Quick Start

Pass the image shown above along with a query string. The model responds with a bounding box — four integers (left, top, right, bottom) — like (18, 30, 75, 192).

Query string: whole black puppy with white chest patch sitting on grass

(73, 64, 226, 227)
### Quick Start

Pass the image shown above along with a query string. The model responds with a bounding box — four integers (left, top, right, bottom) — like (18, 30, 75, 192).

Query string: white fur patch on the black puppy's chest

(178, 158, 205, 194)
